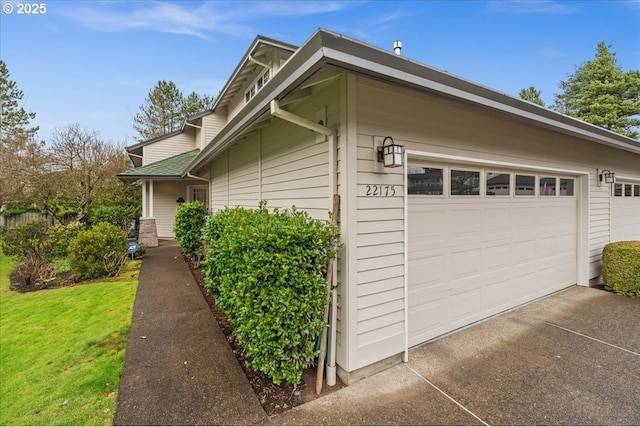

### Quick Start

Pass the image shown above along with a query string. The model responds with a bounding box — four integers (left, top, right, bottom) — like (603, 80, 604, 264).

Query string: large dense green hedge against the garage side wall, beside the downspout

(205, 203, 339, 386)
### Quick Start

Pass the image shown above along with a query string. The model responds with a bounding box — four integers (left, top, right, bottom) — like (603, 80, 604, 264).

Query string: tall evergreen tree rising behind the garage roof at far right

(553, 42, 640, 139)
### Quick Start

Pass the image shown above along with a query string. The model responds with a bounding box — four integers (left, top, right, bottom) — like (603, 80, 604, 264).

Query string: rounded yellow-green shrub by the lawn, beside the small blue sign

(69, 222, 127, 279)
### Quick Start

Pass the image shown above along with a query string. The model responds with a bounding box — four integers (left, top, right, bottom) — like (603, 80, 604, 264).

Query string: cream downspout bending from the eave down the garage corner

(270, 99, 338, 386)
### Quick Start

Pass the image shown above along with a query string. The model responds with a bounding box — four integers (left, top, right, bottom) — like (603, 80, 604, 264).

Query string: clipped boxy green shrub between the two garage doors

(602, 241, 640, 296)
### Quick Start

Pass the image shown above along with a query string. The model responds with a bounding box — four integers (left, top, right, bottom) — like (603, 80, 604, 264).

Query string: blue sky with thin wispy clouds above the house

(0, 0, 640, 145)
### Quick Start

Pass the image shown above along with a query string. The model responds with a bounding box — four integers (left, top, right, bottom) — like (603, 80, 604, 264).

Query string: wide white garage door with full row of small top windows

(407, 165, 577, 346)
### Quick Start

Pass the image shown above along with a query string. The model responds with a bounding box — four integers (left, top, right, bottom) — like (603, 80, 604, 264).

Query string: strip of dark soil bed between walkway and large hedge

(189, 262, 345, 415)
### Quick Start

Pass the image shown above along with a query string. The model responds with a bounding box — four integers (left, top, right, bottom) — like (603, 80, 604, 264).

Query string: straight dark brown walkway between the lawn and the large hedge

(114, 241, 269, 425)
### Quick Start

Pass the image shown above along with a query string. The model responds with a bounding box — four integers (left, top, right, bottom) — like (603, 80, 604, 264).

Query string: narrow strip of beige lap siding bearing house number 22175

(351, 86, 406, 368)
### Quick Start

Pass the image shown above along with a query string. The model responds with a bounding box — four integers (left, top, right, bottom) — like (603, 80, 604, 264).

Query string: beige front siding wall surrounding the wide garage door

(352, 77, 640, 367)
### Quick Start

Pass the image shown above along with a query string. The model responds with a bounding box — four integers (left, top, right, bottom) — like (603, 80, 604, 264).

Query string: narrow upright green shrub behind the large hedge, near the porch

(173, 201, 207, 260)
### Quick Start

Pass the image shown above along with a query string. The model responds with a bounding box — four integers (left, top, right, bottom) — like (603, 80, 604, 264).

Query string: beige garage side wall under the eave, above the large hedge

(210, 78, 339, 220)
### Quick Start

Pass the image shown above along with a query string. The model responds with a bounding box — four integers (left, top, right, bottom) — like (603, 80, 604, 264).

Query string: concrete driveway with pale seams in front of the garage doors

(278, 286, 640, 425)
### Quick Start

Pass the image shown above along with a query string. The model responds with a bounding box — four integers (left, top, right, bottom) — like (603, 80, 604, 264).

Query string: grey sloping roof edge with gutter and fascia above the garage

(185, 29, 640, 174)
